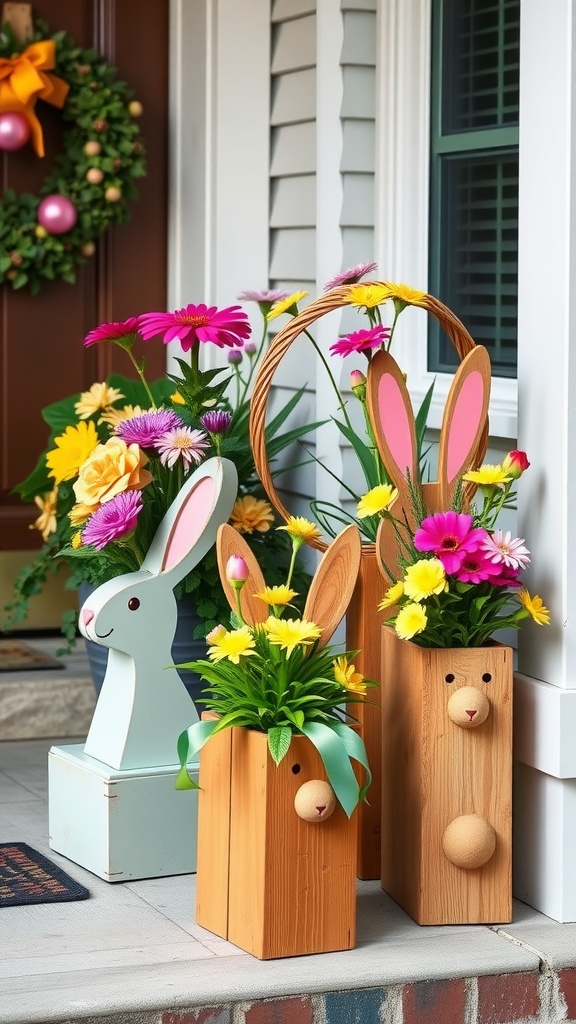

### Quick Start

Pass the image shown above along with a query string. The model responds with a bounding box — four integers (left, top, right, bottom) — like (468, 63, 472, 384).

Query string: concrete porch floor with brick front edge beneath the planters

(0, 739, 576, 1024)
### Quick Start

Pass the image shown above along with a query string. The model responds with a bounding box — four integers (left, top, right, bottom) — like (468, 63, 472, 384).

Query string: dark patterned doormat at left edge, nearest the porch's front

(0, 843, 90, 909)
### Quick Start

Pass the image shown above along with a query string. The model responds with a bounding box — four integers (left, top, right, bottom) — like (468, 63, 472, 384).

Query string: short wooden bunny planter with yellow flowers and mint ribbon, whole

(176, 517, 371, 958)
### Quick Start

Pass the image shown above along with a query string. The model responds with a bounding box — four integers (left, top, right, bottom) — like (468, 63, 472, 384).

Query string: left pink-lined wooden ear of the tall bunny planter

(366, 352, 419, 508)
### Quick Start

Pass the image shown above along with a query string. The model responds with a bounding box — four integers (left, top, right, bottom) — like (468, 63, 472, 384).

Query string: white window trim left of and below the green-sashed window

(376, 0, 518, 439)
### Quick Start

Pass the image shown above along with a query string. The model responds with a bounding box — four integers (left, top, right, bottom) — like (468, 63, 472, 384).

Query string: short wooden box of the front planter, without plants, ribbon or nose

(196, 728, 358, 959)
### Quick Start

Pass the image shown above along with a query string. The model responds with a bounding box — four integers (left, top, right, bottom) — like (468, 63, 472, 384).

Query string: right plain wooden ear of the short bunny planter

(304, 524, 362, 647)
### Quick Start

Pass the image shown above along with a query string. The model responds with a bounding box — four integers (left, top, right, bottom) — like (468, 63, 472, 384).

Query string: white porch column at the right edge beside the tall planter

(513, 0, 576, 921)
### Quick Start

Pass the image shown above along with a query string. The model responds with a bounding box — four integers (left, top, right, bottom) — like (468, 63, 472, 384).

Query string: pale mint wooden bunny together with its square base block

(48, 459, 237, 882)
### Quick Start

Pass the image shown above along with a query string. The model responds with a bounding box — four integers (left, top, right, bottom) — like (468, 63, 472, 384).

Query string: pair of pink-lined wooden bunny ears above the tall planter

(366, 345, 490, 569)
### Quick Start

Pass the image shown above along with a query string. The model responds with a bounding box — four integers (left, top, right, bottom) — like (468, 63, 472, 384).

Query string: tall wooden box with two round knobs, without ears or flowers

(381, 627, 512, 925)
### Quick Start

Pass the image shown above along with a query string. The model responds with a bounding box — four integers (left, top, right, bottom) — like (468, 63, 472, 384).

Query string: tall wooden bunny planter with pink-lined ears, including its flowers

(367, 347, 549, 924)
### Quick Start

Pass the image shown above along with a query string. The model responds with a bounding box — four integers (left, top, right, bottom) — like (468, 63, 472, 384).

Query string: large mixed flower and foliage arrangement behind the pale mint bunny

(4, 293, 315, 696)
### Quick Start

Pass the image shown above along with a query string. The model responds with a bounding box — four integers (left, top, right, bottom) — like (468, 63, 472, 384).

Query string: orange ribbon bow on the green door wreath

(0, 39, 70, 157)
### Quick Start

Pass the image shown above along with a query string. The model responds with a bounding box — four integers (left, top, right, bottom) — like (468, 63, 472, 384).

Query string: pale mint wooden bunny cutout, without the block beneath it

(80, 458, 238, 770)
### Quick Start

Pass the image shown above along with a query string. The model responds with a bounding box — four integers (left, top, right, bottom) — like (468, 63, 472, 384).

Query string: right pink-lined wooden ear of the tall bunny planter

(438, 345, 491, 508)
